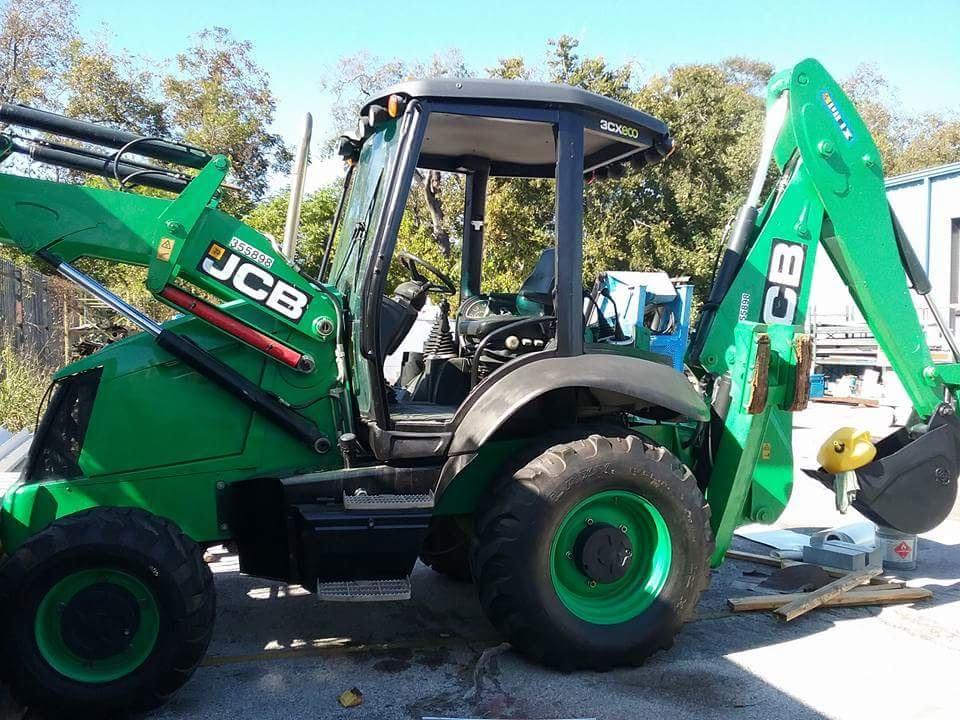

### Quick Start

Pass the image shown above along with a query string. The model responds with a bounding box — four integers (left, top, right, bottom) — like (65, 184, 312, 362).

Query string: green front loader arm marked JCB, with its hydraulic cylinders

(0, 104, 350, 466)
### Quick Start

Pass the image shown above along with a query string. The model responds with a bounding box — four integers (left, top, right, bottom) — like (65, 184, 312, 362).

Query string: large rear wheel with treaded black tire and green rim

(471, 435, 713, 670)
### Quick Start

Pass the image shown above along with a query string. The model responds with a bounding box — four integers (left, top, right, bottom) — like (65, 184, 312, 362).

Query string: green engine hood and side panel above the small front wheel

(0, 308, 342, 551)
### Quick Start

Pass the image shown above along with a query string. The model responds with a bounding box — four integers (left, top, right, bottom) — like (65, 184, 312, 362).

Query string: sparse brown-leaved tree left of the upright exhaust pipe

(163, 27, 291, 212)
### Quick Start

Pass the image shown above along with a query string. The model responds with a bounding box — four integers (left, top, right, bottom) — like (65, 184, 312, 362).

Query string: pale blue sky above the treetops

(78, 0, 960, 188)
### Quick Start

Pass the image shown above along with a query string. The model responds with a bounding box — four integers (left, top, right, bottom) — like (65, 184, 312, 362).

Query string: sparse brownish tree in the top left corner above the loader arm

(0, 0, 76, 107)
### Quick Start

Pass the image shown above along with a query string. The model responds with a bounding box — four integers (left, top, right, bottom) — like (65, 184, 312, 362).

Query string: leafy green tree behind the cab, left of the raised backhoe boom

(486, 36, 773, 290)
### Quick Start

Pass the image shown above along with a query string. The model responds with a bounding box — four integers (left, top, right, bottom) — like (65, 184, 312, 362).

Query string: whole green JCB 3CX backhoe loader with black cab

(0, 60, 960, 716)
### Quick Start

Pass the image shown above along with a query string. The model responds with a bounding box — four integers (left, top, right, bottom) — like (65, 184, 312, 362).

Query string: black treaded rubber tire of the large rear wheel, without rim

(471, 433, 714, 670)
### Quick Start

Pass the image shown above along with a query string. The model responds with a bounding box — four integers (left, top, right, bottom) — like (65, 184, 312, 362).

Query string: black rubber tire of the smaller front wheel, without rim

(0, 508, 216, 718)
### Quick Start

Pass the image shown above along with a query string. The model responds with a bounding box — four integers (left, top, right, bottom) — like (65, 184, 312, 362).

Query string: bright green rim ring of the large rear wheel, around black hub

(550, 490, 672, 625)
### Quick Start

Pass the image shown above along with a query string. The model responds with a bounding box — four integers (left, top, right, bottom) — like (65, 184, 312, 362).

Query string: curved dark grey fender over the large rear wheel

(447, 352, 710, 456)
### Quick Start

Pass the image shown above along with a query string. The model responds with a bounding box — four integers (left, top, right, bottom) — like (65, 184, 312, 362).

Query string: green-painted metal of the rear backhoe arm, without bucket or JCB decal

(688, 60, 960, 565)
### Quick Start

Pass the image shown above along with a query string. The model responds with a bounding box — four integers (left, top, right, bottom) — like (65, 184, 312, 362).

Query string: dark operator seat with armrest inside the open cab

(457, 247, 556, 345)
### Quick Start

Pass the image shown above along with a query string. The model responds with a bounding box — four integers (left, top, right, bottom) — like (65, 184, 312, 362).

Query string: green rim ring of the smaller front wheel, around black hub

(34, 569, 160, 683)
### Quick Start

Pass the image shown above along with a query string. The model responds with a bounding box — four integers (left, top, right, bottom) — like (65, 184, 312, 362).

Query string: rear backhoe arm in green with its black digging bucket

(688, 60, 960, 564)
